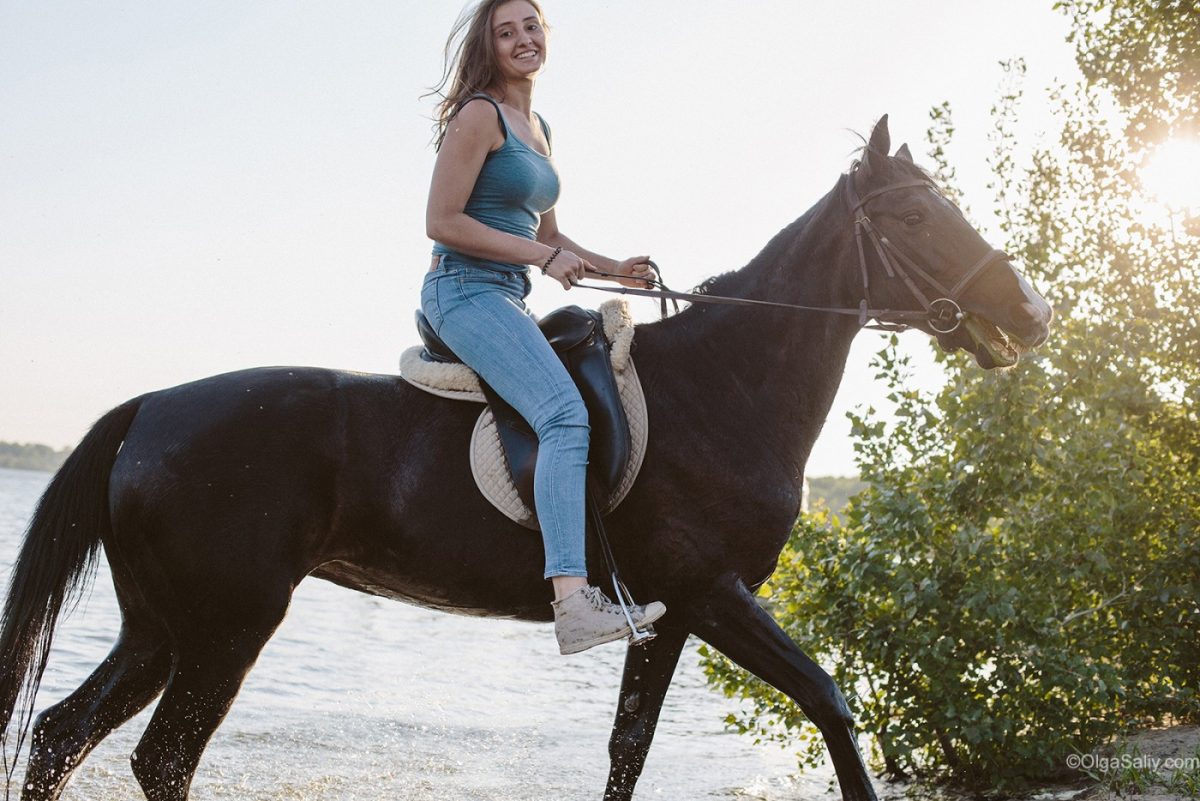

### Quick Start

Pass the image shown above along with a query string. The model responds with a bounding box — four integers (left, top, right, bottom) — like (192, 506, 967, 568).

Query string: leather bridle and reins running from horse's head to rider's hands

(575, 173, 1009, 333)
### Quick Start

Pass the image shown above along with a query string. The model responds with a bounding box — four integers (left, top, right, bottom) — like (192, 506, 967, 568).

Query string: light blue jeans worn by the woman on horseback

(421, 258, 589, 578)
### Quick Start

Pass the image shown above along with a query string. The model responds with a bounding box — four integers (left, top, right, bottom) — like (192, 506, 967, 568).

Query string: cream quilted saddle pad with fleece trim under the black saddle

(400, 299, 649, 530)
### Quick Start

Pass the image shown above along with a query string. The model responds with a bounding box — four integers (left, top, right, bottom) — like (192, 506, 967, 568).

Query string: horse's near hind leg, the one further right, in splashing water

(132, 586, 292, 801)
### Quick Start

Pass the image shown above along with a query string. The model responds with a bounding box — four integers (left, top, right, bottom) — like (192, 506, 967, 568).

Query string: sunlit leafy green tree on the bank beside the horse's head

(706, 18, 1200, 788)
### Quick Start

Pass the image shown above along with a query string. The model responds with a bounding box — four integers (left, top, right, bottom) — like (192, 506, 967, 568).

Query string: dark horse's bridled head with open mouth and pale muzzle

(847, 115, 1054, 368)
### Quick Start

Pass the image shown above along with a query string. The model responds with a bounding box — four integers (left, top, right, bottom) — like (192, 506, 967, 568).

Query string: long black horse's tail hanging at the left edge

(0, 398, 142, 762)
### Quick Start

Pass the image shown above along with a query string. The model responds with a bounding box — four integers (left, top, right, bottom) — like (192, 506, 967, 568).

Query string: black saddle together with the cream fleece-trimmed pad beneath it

(400, 299, 648, 530)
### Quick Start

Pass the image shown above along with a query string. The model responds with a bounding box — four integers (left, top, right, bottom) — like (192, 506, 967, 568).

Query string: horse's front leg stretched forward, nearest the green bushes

(689, 576, 876, 801)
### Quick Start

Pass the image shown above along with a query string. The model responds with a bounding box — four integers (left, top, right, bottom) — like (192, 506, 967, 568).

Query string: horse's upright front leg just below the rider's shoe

(604, 613, 688, 801)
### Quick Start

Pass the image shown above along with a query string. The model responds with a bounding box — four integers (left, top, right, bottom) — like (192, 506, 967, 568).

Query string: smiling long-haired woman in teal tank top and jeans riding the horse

(421, 0, 666, 654)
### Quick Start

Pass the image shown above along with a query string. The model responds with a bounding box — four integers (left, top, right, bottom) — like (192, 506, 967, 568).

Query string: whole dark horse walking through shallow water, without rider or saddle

(0, 118, 1051, 801)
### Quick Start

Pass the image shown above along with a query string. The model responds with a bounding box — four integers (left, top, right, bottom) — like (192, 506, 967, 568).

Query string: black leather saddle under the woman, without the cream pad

(416, 306, 632, 510)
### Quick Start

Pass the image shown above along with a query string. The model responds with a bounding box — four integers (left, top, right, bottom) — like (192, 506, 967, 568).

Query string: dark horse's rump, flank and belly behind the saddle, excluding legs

(109, 367, 545, 616)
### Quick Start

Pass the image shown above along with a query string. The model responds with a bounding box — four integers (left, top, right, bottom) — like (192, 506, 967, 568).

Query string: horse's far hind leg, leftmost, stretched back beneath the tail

(20, 624, 170, 801)
